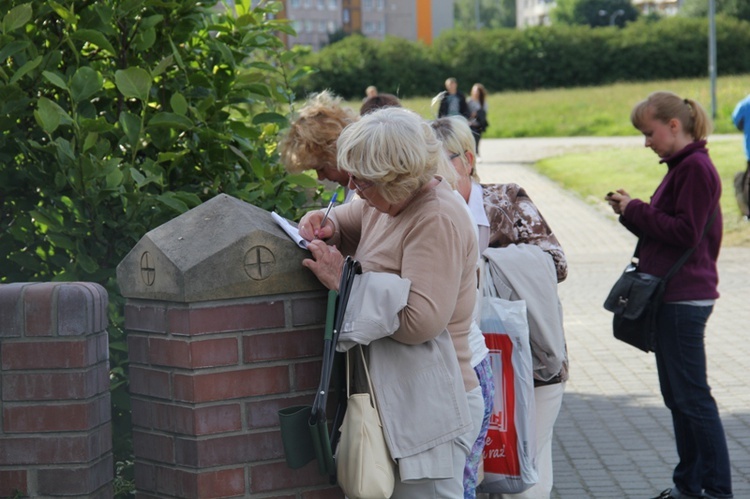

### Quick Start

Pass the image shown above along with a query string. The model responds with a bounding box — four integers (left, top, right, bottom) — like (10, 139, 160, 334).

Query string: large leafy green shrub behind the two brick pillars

(0, 0, 318, 492)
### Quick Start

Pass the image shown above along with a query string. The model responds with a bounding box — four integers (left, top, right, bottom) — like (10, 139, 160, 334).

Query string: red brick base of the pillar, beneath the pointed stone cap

(125, 292, 343, 499)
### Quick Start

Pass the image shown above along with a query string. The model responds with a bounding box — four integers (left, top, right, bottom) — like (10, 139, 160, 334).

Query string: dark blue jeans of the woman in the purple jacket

(656, 303, 732, 498)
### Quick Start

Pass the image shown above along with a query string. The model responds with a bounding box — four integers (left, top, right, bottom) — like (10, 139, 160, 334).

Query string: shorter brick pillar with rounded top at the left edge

(0, 282, 113, 499)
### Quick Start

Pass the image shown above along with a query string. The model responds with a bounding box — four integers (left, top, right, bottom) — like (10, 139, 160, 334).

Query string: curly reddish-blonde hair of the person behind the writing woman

(279, 90, 358, 173)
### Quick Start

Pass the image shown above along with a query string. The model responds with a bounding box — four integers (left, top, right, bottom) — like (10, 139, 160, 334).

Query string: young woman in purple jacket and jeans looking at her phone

(607, 92, 733, 499)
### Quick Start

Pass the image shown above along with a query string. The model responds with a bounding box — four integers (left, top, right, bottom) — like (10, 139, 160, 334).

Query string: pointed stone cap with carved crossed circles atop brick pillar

(117, 194, 323, 303)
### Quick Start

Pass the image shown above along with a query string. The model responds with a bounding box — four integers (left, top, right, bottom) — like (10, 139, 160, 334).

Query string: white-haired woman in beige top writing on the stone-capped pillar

(300, 108, 483, 499)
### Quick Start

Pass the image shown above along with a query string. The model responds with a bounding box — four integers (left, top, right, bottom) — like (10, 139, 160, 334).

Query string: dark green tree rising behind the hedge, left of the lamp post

(552, 0, 639, 28)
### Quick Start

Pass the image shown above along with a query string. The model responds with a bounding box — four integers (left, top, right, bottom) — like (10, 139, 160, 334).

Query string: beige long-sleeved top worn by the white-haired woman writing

(327, 181, 479, 392)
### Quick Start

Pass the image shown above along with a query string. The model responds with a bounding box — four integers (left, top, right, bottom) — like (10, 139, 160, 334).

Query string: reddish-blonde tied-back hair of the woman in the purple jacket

(630, 91, 711, 140)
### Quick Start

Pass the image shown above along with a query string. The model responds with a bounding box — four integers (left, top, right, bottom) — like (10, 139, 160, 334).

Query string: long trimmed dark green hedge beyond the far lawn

(296, 16, 750, 98)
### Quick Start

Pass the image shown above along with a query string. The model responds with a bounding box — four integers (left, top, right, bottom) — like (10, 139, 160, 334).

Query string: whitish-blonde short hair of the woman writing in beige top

(338, 107, 455, 204)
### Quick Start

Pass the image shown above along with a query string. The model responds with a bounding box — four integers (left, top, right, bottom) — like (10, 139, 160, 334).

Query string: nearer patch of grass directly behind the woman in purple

(536, 136, 750, 246)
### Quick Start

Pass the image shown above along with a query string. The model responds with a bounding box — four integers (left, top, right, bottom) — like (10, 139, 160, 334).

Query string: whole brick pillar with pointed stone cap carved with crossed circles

(118, 195, 343, 499)
